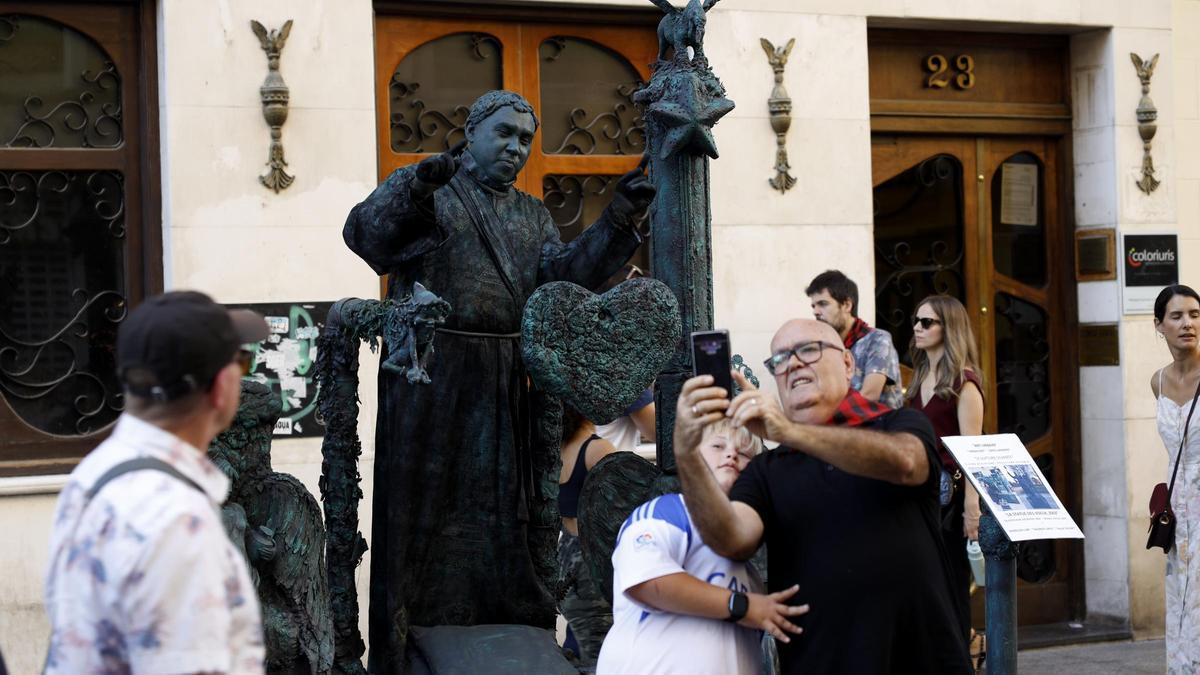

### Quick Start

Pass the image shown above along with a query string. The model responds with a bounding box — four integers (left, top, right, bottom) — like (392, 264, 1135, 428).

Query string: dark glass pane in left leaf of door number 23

(875, 155, 966, 365)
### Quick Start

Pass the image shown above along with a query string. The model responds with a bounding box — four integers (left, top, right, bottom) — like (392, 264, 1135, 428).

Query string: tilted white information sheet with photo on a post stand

(942, 434, 1084, 542)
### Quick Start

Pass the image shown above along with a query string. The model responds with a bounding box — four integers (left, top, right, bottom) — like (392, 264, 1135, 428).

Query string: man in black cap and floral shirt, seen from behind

(46, 292, 268, 673)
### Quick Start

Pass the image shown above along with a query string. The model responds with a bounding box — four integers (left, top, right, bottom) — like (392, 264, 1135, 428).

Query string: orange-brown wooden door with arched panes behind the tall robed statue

(376, 16, 658, 288)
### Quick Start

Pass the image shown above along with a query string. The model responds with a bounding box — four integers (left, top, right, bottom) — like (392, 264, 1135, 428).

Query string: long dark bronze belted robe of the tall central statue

(343, 154, 638, 673)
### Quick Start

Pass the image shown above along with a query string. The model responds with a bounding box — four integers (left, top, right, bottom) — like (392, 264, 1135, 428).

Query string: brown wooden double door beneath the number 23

(872, 135, 1082, 625)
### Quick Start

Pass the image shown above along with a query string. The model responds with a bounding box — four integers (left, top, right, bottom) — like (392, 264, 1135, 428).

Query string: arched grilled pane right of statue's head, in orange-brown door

(538, 37, 646, 155)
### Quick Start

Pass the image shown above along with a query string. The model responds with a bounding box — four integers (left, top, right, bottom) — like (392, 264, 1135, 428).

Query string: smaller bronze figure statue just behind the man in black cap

(209, 381, 334, 675)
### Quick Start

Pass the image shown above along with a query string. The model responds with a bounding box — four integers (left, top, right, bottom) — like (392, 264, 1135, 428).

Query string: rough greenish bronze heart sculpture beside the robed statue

(521, 279, 683, 424)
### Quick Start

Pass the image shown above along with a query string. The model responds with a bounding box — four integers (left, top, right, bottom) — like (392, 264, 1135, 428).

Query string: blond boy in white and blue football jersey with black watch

(596, 420, 809, 675)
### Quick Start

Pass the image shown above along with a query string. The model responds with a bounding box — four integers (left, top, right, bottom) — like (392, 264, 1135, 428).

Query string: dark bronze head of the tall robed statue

(467, 90, 538, 184)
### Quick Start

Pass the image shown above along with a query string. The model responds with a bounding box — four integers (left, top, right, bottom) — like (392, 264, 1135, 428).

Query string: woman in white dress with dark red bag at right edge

(1150, 281, 1200, 675)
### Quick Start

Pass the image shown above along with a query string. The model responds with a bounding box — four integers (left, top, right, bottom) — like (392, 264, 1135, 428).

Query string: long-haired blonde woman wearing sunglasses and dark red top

(905, 295, 983, 641)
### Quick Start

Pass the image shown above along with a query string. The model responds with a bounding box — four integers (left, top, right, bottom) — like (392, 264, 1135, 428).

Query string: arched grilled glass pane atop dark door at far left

(0, 14, 124, 148)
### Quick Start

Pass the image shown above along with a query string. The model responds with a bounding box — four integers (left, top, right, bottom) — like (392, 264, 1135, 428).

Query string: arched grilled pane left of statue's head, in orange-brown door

(389, 32, 503, 153)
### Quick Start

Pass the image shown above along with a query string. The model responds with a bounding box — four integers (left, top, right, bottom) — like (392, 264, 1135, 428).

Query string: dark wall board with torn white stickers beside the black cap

(227, 303, 332, 438)
